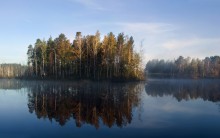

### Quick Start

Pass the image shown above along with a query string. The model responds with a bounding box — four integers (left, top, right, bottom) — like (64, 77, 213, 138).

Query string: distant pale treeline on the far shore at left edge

(0, 64, 27, 78)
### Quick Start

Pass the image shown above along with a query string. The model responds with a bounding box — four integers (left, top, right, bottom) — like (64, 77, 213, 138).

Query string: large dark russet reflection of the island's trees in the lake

(28, 83, 143, 128)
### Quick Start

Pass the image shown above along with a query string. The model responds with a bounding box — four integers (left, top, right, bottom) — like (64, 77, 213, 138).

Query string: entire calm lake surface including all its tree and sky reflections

(0, 80, 220, 138)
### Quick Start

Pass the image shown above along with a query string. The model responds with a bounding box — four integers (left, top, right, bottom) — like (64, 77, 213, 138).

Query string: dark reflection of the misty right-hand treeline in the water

(145, 80, 220, 102)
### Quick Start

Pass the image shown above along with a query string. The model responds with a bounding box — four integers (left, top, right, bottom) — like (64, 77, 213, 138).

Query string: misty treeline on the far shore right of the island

(145, 56, 220, 78)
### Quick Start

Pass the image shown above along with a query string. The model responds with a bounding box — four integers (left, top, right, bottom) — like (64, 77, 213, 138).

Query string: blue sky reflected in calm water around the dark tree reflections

(0, 80, 220, 137)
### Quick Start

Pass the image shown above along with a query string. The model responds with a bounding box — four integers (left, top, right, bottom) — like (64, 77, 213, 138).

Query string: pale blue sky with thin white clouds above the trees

(0, 0, 220, 64)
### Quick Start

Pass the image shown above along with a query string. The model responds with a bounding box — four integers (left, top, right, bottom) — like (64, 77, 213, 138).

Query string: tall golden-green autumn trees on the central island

(27, 32, 143, 80)
